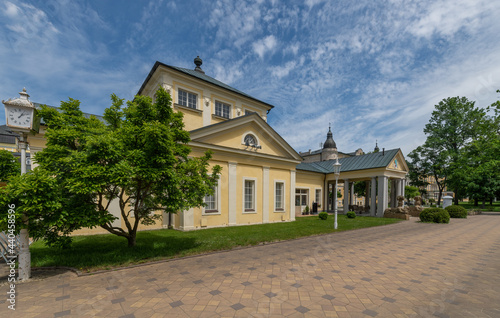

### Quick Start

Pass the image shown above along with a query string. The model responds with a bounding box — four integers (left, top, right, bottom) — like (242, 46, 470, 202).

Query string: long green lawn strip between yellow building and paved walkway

(30, 215, 400, 272)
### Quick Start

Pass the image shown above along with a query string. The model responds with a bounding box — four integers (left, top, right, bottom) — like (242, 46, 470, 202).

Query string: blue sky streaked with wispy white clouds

(0, 0, 500, 154)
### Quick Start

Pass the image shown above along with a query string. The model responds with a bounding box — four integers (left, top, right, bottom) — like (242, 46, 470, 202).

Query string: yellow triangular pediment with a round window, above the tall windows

(190, 114, 301, 160)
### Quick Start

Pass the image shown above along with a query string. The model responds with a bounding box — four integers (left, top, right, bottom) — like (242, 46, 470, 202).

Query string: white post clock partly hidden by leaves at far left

(2, 88, 40, 280)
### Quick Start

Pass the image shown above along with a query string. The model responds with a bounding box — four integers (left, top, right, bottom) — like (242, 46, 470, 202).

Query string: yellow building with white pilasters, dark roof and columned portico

(3, 57, 407, 234)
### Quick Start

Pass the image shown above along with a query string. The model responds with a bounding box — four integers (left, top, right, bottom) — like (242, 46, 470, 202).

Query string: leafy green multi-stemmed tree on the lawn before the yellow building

(0, 88, 221, 246)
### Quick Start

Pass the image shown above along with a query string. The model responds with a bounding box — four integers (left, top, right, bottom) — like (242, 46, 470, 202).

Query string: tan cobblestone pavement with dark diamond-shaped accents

(0, 215, 500, 318)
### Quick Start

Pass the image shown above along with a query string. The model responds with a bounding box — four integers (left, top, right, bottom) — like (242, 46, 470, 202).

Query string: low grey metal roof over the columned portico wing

(297, 148, 399, 173)
